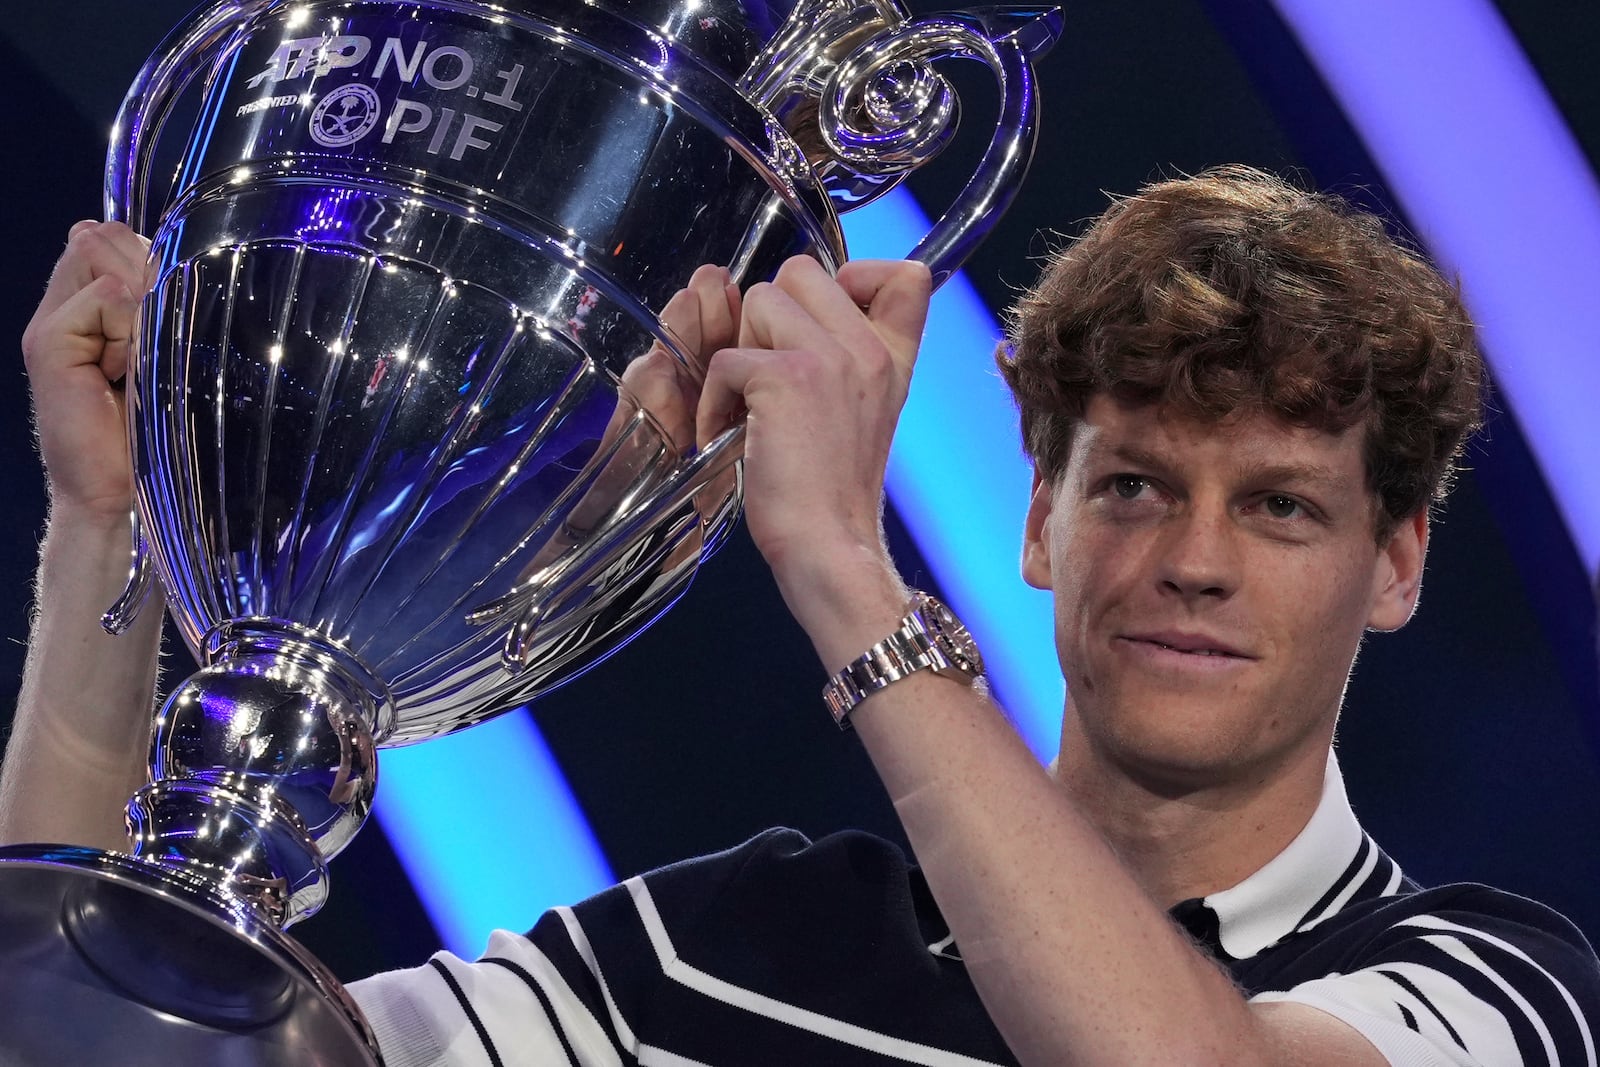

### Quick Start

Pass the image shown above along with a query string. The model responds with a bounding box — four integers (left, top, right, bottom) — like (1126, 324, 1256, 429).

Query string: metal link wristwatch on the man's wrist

(822, 592, 984, 729)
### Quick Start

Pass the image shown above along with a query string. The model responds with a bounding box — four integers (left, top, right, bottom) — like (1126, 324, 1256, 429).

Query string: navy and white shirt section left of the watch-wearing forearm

(354, 832, 1014, 1067)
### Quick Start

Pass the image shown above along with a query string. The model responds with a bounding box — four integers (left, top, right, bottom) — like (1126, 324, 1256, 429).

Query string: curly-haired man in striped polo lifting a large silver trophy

(0, 168, 1600, 1067)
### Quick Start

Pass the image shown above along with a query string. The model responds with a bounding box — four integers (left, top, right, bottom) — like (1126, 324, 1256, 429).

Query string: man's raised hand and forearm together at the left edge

(0, 222, 162, 848)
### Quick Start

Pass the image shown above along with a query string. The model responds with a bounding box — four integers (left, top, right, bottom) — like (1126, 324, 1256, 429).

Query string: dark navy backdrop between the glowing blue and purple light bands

(0, 0, 1600, 977)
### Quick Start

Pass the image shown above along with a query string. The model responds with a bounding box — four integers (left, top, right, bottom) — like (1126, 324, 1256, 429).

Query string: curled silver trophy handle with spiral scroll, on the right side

(818, 6, 1061, 288)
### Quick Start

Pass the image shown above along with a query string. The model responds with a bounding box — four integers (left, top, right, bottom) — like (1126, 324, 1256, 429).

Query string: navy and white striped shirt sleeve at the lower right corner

(1251, 886, 1600, 1067)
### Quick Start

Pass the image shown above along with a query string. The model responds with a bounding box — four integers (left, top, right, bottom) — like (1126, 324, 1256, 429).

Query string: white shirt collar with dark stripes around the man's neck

(1173, 752, 1402, 960)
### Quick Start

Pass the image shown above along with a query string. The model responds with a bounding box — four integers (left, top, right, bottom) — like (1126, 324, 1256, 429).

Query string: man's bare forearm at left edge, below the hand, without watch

(0, 509, 162, 849)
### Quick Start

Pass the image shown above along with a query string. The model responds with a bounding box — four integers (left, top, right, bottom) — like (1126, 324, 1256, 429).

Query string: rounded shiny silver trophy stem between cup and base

(128, 621, 389, 928)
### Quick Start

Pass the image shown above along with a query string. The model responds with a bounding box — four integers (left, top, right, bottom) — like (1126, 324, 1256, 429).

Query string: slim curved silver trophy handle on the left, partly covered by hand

(101, 0, 270, 635)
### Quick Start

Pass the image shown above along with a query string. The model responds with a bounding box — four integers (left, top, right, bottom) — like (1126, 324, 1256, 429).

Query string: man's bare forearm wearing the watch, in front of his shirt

(786, 558, 1272, 1067)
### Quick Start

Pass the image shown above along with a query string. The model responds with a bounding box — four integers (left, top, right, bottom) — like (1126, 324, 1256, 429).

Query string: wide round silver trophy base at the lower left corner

(0, 845, 381, 1067)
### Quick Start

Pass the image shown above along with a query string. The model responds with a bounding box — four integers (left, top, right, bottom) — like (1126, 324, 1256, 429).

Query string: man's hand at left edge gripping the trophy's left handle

(22, 221, 154, 523)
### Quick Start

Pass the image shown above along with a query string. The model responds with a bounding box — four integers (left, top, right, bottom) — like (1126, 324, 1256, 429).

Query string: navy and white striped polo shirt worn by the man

(350, 760, 1600, 1067)
